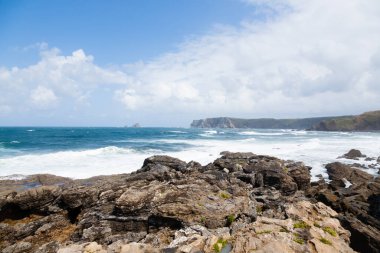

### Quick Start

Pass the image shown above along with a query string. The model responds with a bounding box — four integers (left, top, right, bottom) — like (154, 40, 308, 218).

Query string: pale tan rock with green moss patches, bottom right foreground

(232, 201, 354, 253)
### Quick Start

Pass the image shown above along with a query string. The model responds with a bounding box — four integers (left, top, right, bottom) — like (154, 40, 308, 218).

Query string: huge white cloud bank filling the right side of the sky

(117, 0, 380, 116)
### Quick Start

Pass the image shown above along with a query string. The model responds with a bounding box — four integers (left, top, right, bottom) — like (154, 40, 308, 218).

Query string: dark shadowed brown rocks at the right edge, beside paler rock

(310, 162, 380, 252)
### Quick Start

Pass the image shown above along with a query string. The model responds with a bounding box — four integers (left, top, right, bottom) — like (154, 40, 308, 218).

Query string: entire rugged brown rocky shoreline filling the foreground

(0, 152, 380, 253)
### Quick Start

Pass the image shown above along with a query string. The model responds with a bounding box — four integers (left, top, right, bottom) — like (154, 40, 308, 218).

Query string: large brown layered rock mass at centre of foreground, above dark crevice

(116, 181, 255, 227)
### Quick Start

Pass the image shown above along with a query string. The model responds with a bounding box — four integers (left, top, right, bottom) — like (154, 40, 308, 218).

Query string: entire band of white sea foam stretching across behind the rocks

(0, 131, 380, 180)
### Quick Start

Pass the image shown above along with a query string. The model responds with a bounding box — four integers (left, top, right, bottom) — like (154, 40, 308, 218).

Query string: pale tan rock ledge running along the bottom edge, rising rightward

(52, 201, 354, 253)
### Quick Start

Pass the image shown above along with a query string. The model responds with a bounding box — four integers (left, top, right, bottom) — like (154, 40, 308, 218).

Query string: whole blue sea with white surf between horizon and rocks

(0, 127, 380, 180)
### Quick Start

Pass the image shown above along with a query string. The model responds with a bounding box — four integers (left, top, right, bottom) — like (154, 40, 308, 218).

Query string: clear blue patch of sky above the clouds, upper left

(0, 0, 252, 66)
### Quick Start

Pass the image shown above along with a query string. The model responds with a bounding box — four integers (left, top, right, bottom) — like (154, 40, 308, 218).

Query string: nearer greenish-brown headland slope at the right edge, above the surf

(311, 111, 380, 131)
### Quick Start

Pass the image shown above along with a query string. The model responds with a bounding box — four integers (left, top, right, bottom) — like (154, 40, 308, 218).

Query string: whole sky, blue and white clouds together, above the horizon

(0, 0, 380, 127)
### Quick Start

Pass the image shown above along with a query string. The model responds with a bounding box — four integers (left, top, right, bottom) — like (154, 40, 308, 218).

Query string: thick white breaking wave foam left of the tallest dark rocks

(0, 146, 150, 178)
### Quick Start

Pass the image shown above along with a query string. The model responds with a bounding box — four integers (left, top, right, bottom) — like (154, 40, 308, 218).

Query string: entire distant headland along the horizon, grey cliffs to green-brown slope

(191, 111, 380, 131)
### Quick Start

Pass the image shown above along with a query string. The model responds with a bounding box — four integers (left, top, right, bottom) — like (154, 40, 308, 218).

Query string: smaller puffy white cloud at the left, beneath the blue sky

(0, 43, 127, 111)
